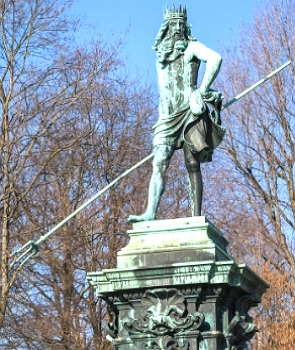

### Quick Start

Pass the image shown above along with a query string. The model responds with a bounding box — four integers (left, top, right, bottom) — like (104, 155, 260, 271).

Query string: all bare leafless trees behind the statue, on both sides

(0, 0, 295, 350)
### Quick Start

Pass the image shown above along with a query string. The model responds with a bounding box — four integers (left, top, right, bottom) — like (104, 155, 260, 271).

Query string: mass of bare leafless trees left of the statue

(0, 0, 154, 350)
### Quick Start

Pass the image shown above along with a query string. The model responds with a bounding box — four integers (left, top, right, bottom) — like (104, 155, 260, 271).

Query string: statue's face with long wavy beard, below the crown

(157, 18, 188, 64)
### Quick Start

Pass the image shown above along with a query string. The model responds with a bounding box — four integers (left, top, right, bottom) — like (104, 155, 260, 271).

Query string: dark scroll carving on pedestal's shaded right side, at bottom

(228, 316, 258, 350)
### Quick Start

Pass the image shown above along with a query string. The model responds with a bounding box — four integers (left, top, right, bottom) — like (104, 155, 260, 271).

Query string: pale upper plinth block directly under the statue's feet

(118, 216, 231, 268)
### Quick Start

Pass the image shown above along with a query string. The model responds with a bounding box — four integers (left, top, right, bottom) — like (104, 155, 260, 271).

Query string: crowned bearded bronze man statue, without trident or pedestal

(129, 6, 225, 222)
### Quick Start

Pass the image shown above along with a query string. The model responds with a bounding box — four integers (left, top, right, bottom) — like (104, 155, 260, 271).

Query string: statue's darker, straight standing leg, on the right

(183, 144, 203, 216)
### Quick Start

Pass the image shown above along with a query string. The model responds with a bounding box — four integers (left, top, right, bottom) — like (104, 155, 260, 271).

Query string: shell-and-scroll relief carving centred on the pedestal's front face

(124, 288, 205, 336)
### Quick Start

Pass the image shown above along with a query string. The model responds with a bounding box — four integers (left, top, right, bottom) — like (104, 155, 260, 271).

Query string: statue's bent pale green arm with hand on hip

(184, 41, 222, 96)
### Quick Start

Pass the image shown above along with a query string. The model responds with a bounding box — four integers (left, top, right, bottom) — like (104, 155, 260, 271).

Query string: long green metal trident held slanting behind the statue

(10, 61, 291, 269)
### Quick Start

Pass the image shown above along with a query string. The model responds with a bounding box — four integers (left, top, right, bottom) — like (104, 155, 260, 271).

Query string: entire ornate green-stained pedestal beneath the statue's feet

(87, 216, 268, 350)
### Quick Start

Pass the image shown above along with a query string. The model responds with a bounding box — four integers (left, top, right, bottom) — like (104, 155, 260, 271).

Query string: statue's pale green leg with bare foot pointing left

(128, 145, 174, 222)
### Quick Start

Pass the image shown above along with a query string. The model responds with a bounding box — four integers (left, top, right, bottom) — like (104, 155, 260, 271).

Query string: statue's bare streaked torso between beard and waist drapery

(157, 55, 200, 119)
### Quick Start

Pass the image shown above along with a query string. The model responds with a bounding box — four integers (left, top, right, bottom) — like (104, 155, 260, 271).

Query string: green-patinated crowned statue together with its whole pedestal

(87, 7, 276, 350)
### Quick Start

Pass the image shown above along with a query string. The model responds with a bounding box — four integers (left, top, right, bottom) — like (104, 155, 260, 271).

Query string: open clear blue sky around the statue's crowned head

(73, 0, 263, 83)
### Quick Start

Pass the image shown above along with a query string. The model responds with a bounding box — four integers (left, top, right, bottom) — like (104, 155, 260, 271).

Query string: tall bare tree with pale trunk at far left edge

(0, 0, 79, 325)
